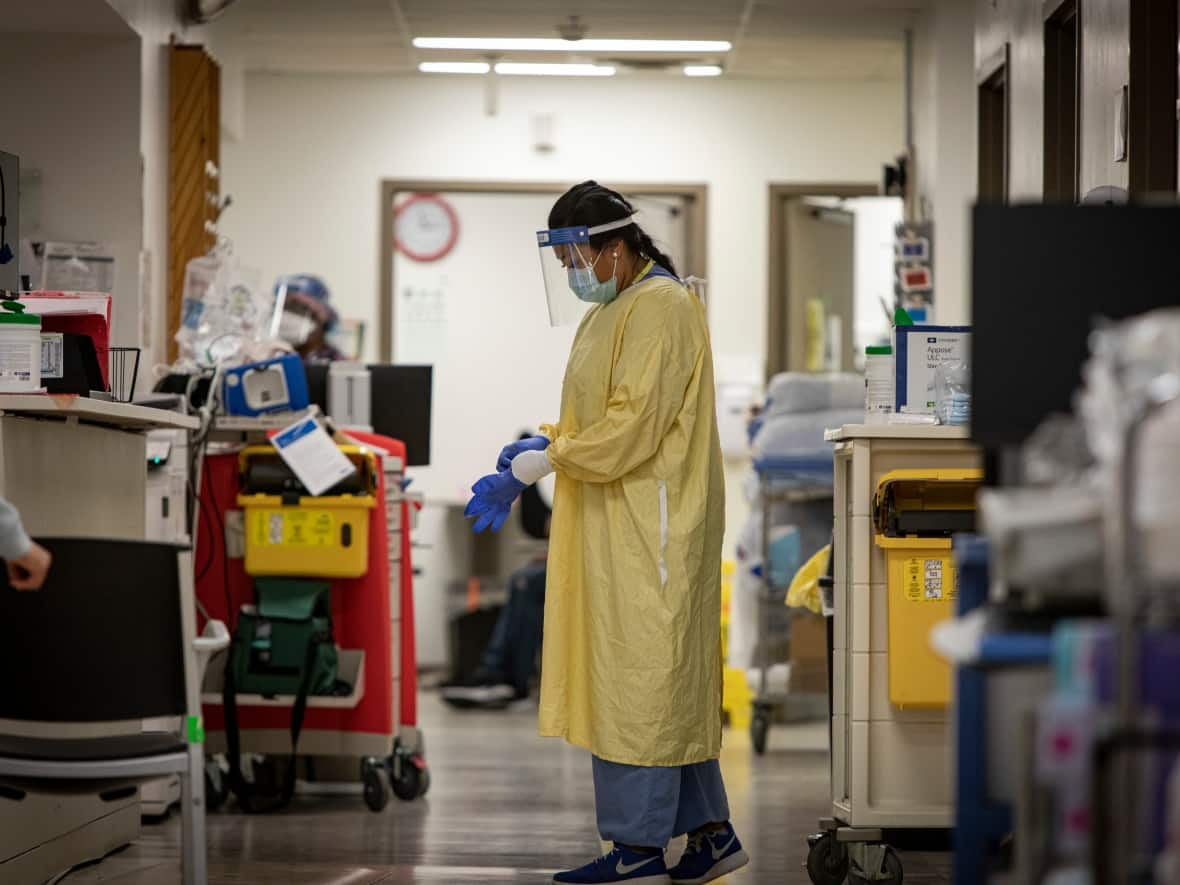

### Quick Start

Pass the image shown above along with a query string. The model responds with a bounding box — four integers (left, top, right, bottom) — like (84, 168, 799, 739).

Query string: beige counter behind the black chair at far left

(0, 394, 197, 883)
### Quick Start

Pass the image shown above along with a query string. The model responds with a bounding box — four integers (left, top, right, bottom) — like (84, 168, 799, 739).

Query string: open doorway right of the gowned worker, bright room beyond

(766, 183, 903, 378)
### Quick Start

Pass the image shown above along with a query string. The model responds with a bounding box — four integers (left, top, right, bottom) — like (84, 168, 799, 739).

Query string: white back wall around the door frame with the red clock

(223, 72, 902, 375)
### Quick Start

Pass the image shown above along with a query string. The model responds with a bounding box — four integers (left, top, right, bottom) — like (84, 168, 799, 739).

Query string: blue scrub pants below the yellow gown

(594, 756, 729, 848)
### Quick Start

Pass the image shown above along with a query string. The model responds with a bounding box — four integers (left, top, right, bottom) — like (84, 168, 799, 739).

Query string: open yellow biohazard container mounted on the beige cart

(874, 470, 983, 708)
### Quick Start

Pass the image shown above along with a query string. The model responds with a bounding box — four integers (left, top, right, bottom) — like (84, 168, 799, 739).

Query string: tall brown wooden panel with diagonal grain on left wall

(165, 46, 221, 361)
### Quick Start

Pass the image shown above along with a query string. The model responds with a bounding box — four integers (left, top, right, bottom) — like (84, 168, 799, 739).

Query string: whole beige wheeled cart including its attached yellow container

(807, 424, 981, 885)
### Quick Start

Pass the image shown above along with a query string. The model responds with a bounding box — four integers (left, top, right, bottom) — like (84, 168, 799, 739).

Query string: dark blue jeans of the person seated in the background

(479, 563, 545, 697)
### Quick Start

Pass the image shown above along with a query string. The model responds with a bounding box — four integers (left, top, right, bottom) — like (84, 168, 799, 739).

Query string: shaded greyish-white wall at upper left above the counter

(0, 30, 144, 346)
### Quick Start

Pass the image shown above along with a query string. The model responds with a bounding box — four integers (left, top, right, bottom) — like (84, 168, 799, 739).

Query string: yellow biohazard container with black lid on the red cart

(237, 446, 376, 578)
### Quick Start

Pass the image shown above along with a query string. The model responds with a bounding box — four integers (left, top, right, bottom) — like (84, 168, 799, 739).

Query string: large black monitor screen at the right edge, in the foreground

(971, 205, 1180, 448)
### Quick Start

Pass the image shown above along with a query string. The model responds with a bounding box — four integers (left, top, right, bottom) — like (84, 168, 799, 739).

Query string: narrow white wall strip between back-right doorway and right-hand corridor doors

(913, 0, 978, 325)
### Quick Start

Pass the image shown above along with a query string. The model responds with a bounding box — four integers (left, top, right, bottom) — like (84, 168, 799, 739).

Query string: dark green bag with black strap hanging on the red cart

(222, 578, 350, 813)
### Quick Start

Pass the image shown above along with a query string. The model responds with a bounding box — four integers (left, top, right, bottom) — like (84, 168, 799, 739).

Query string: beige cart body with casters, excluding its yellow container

(807, 425, 979, 885)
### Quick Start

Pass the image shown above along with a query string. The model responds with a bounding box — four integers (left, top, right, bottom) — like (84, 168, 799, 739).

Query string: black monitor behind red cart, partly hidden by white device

(307, 362, 434, 467)
